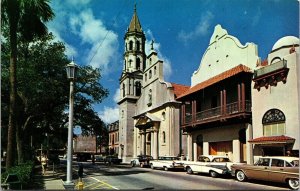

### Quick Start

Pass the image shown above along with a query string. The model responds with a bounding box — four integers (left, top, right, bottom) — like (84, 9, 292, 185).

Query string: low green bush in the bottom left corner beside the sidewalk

(1, 161, 34, 185)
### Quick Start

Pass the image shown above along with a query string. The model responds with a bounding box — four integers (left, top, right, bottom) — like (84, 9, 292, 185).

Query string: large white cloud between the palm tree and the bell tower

(49, 0, 120, 75)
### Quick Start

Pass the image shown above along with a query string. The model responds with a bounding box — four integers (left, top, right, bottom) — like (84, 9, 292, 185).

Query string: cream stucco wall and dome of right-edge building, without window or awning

(252, 36, 300, 158)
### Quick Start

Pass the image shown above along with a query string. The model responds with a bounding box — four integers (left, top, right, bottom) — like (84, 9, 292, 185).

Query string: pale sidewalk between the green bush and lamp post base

(32, 165, 65, 190)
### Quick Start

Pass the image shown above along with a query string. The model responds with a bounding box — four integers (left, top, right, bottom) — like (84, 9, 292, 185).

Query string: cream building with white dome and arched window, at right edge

(249, 36, 300, 159)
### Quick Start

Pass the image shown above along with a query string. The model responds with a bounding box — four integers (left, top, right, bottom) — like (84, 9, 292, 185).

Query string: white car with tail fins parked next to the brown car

(184, 155, 239, 178)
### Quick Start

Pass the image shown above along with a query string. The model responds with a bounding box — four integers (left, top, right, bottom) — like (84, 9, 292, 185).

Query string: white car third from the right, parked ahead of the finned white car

(150, 156, 184, 171)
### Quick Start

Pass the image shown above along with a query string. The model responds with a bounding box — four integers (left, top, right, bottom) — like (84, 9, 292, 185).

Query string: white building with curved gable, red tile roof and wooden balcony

(177, 25, 259, 163)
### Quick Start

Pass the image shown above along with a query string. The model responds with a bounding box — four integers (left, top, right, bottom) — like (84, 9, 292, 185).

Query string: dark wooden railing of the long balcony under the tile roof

(185, 100, 251, 124)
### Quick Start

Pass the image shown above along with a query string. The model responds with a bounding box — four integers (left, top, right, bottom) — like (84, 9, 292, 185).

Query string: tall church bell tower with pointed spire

(118, 5, 146, 162)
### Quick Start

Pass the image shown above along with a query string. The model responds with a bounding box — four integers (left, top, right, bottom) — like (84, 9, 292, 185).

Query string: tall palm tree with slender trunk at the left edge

(1, 0, 54, 169)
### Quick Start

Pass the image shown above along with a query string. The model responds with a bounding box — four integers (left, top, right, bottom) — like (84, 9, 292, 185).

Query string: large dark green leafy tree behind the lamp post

(1, 31, 108, 166)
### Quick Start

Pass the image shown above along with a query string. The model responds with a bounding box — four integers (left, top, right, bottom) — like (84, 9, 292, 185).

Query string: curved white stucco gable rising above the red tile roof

(191, 25, 258, 86)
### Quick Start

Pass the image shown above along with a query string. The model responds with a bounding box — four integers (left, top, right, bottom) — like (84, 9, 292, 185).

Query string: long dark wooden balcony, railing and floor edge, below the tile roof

(181, 100, 251, 128)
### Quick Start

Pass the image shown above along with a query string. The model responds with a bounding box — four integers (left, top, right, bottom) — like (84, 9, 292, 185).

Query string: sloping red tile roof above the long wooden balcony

(177, 64, 253, 99)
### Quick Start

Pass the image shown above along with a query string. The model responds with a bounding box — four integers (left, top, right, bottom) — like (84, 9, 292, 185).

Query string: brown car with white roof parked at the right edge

(231, 156, 299, 189)
